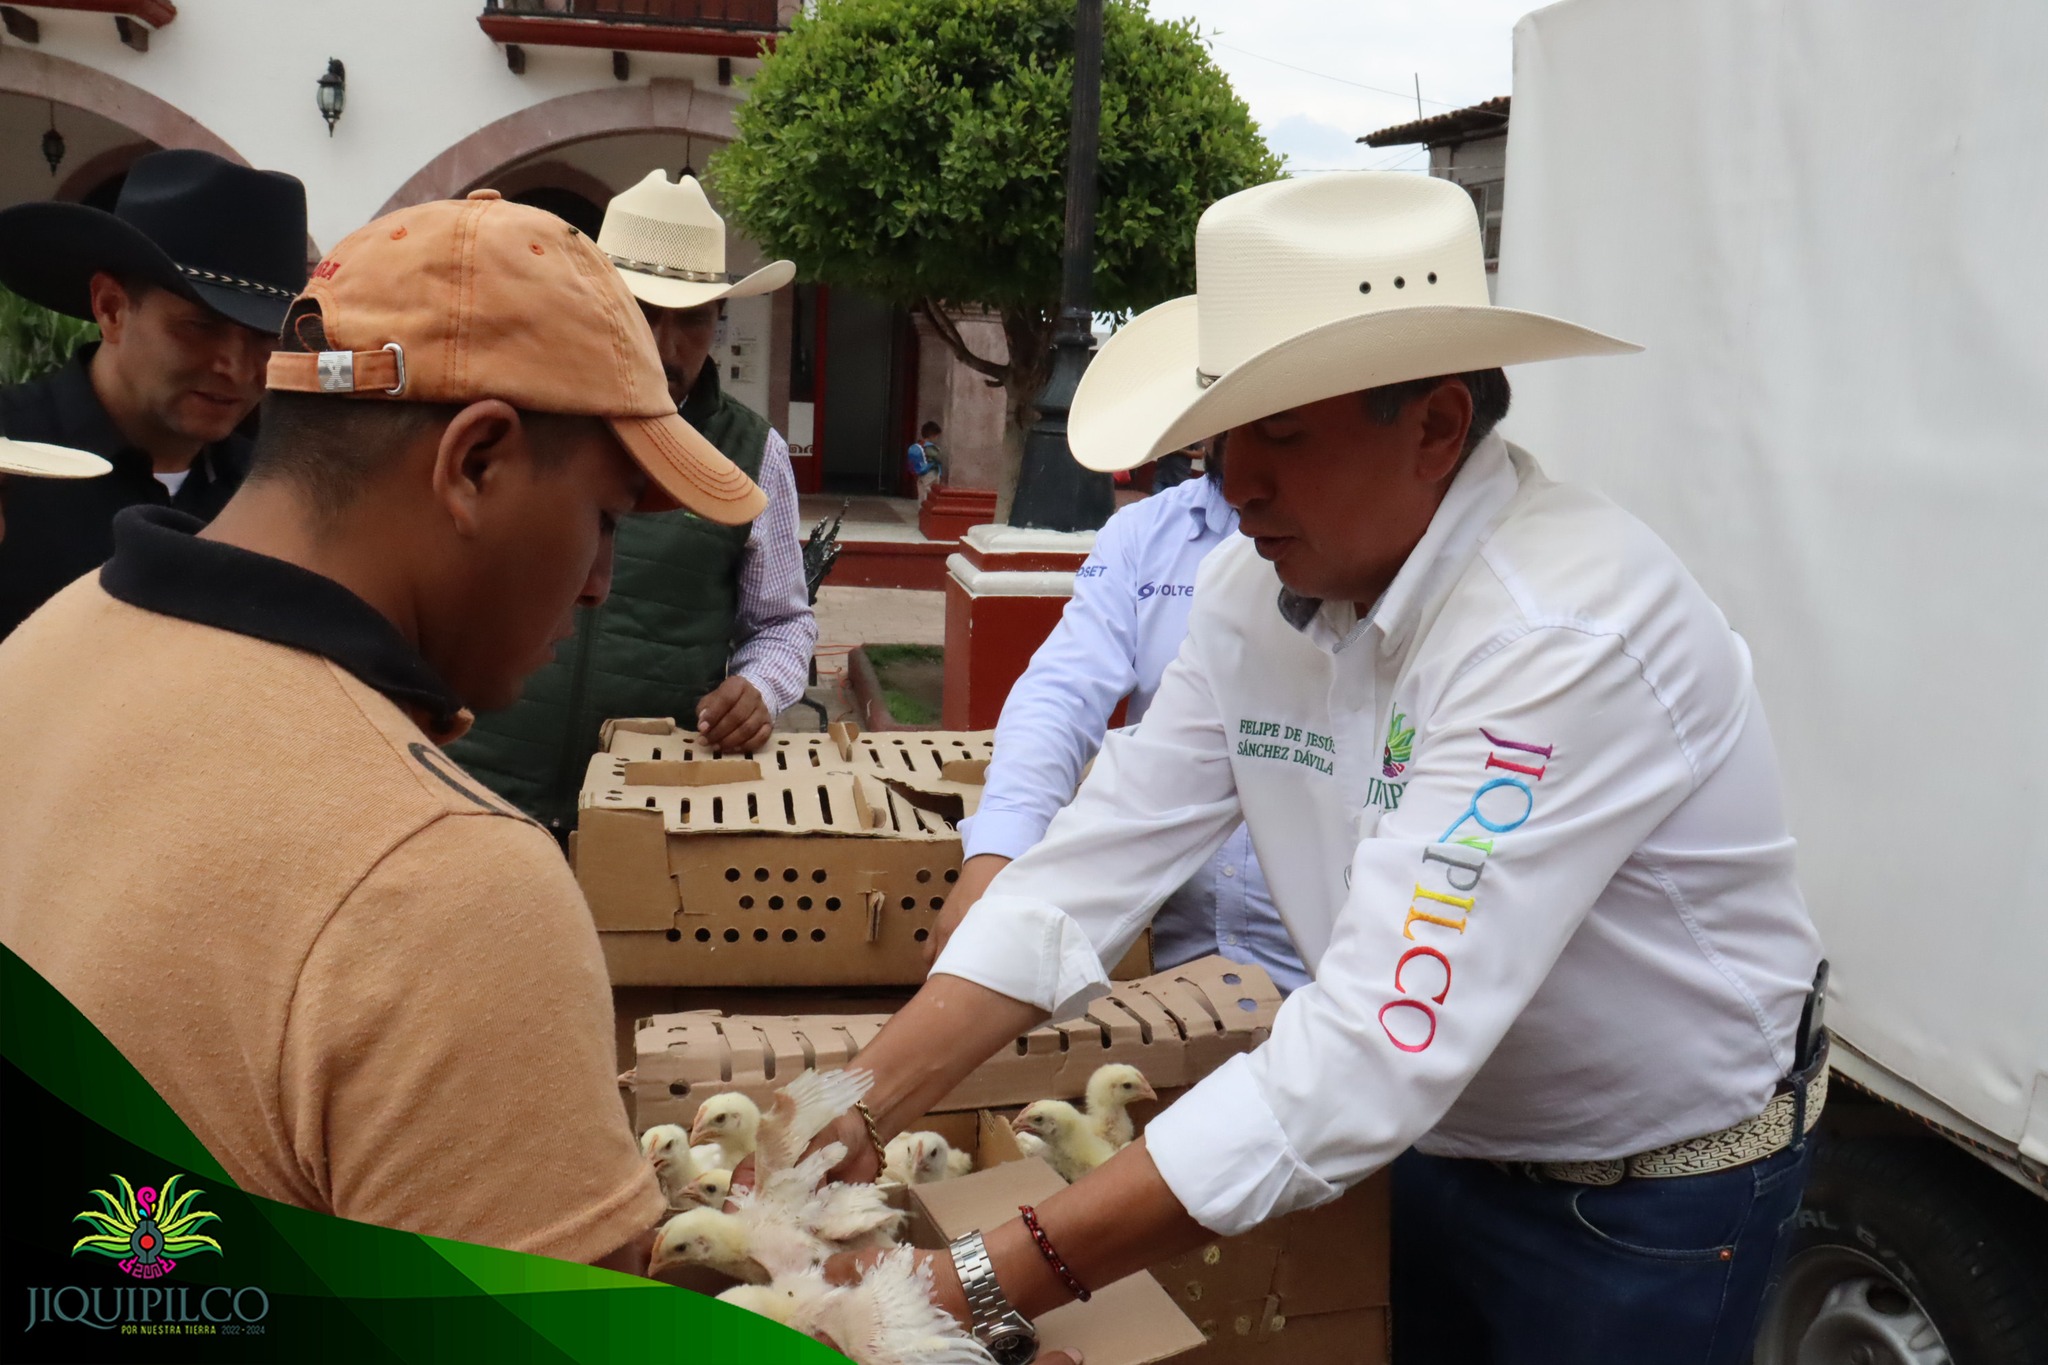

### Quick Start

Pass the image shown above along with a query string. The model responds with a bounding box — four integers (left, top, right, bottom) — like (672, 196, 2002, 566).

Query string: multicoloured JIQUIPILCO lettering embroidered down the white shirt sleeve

(1378, 729, 1554, 1052)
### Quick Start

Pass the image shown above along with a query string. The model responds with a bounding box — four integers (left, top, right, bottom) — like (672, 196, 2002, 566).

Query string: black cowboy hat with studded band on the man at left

(0, 149, 305, 336)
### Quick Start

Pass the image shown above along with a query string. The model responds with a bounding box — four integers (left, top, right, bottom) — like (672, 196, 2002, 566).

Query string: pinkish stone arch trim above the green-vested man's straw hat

(377, 80, 739, 217)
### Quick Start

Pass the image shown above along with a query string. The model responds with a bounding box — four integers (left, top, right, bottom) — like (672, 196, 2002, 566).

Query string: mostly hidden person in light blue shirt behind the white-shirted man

(948, 458, 1309, 990)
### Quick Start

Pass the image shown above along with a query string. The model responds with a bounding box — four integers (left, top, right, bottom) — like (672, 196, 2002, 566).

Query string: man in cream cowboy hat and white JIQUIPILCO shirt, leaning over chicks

(798, 172, 1825, 1363)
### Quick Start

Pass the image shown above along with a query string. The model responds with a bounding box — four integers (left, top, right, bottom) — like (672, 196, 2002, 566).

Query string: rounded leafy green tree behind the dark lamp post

(709, 0, 1280, 444)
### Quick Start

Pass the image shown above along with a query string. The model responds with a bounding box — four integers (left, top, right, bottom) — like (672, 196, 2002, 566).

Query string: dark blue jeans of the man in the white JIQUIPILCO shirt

(1393, 1142, 1812, 1365)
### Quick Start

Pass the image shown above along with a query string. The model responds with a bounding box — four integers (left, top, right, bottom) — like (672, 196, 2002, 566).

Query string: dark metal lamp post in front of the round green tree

(1010, 0, 1116, 530)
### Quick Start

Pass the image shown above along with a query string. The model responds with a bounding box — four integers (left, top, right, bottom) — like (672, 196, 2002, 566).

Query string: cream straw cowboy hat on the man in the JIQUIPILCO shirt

(1067, 170, 1642, 471)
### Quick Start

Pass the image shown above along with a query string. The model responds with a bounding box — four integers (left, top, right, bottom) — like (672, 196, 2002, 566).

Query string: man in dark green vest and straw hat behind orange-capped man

(449, 170, 817, 837)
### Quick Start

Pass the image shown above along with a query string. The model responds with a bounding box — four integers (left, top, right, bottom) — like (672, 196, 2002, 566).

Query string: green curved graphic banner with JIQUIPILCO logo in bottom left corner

(0, 948, 842, 1365)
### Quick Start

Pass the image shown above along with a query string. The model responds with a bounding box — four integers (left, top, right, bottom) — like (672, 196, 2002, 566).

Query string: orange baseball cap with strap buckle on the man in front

(266, 190, 768, 526)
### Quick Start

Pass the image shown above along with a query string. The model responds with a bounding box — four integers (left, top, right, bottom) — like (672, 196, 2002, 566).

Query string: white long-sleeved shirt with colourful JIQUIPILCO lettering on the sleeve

(934, 436, 1819, 1234)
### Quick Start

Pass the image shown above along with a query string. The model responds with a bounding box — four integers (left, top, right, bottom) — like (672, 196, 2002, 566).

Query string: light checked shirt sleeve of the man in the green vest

(729, 428, 817, 716)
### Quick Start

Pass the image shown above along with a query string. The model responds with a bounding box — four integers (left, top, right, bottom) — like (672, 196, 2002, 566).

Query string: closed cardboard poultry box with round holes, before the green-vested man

(571, 720, 991, 986)
